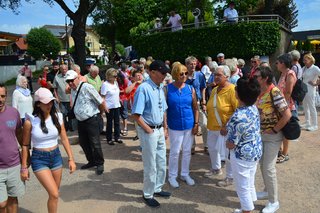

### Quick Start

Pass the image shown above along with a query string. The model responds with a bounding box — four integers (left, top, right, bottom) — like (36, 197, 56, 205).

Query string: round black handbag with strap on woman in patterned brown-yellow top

(270, 89, 301, 140)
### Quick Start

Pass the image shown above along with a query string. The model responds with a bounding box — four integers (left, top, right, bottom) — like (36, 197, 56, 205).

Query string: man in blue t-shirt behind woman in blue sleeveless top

(185, 56, 208, 154)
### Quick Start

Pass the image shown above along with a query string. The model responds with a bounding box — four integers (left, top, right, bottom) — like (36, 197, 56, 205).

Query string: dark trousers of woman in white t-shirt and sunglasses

(106, 108, 120, 141)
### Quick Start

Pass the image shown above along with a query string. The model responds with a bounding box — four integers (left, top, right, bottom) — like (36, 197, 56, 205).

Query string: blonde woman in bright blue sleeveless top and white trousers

(166, 62, 199, 188)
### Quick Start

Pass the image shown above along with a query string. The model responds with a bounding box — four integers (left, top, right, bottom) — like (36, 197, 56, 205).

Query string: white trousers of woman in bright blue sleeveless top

(169, 129, 194, 179)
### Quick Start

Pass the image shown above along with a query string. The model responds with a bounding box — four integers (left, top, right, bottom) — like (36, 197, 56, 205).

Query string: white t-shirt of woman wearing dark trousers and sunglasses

(101, 81, 120, 109)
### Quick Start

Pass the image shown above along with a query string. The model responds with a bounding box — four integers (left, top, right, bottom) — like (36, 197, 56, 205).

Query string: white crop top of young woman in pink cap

(26, 112, 63, 149)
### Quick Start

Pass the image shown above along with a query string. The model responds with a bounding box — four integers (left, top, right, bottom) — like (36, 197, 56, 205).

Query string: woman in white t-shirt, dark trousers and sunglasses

(101, 68, 122, 145)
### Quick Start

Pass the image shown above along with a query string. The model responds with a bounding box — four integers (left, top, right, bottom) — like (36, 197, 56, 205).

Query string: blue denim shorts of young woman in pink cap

(31, 147, 62, 172)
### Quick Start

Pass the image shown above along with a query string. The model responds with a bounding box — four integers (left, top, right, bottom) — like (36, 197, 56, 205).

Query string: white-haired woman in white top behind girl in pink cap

(12, 76, 33, 123)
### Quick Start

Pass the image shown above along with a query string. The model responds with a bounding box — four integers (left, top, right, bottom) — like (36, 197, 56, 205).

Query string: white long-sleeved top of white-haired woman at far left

(12, 89, 33, 118)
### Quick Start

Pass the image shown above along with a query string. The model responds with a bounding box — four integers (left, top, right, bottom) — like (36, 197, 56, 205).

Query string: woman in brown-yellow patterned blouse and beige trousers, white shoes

(253, 67, 291, 213)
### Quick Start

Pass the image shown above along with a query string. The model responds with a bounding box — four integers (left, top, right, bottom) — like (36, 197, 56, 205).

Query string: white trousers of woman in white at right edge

(302, 87, 318, 126)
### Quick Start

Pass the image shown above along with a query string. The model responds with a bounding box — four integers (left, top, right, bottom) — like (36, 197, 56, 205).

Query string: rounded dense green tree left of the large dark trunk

(27, 28, 62, 59)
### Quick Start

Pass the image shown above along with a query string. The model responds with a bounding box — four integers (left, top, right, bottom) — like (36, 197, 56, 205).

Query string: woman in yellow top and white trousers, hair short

(204, 66, 238, 186)
